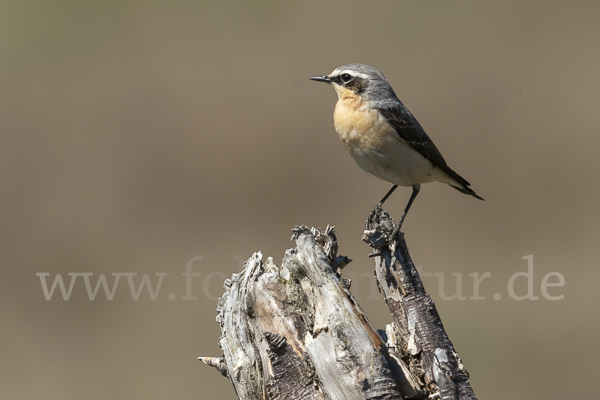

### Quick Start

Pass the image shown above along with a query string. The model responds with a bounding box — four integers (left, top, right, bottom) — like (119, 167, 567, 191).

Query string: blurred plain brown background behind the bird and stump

(0, 0, 600, 399)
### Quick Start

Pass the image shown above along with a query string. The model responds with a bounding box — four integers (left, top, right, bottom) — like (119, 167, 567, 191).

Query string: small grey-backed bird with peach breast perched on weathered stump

(310, 64, 484, 231)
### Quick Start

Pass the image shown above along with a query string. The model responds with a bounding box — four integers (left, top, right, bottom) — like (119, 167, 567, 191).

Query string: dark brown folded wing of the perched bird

(378, 105, 470, 187)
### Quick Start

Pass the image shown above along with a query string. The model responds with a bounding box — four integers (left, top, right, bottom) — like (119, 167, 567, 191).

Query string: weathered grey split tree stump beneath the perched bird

(199, 208, 476, 400)
